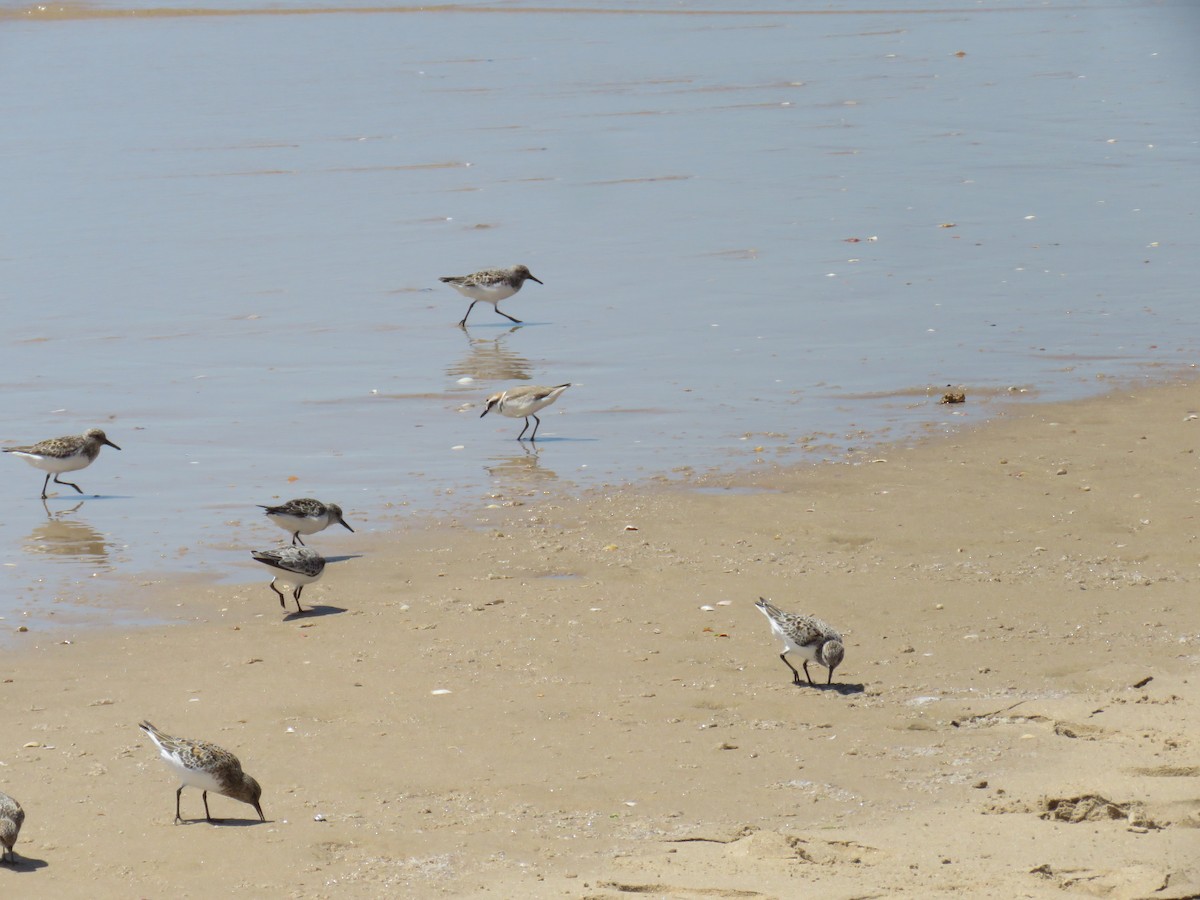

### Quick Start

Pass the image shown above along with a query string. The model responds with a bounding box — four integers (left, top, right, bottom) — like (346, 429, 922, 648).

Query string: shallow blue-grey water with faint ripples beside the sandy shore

(0, 2, 1200, 617)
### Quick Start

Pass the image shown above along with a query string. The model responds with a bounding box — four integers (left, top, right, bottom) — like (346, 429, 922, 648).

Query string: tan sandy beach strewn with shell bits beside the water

(0, 383, 1200, 900)
